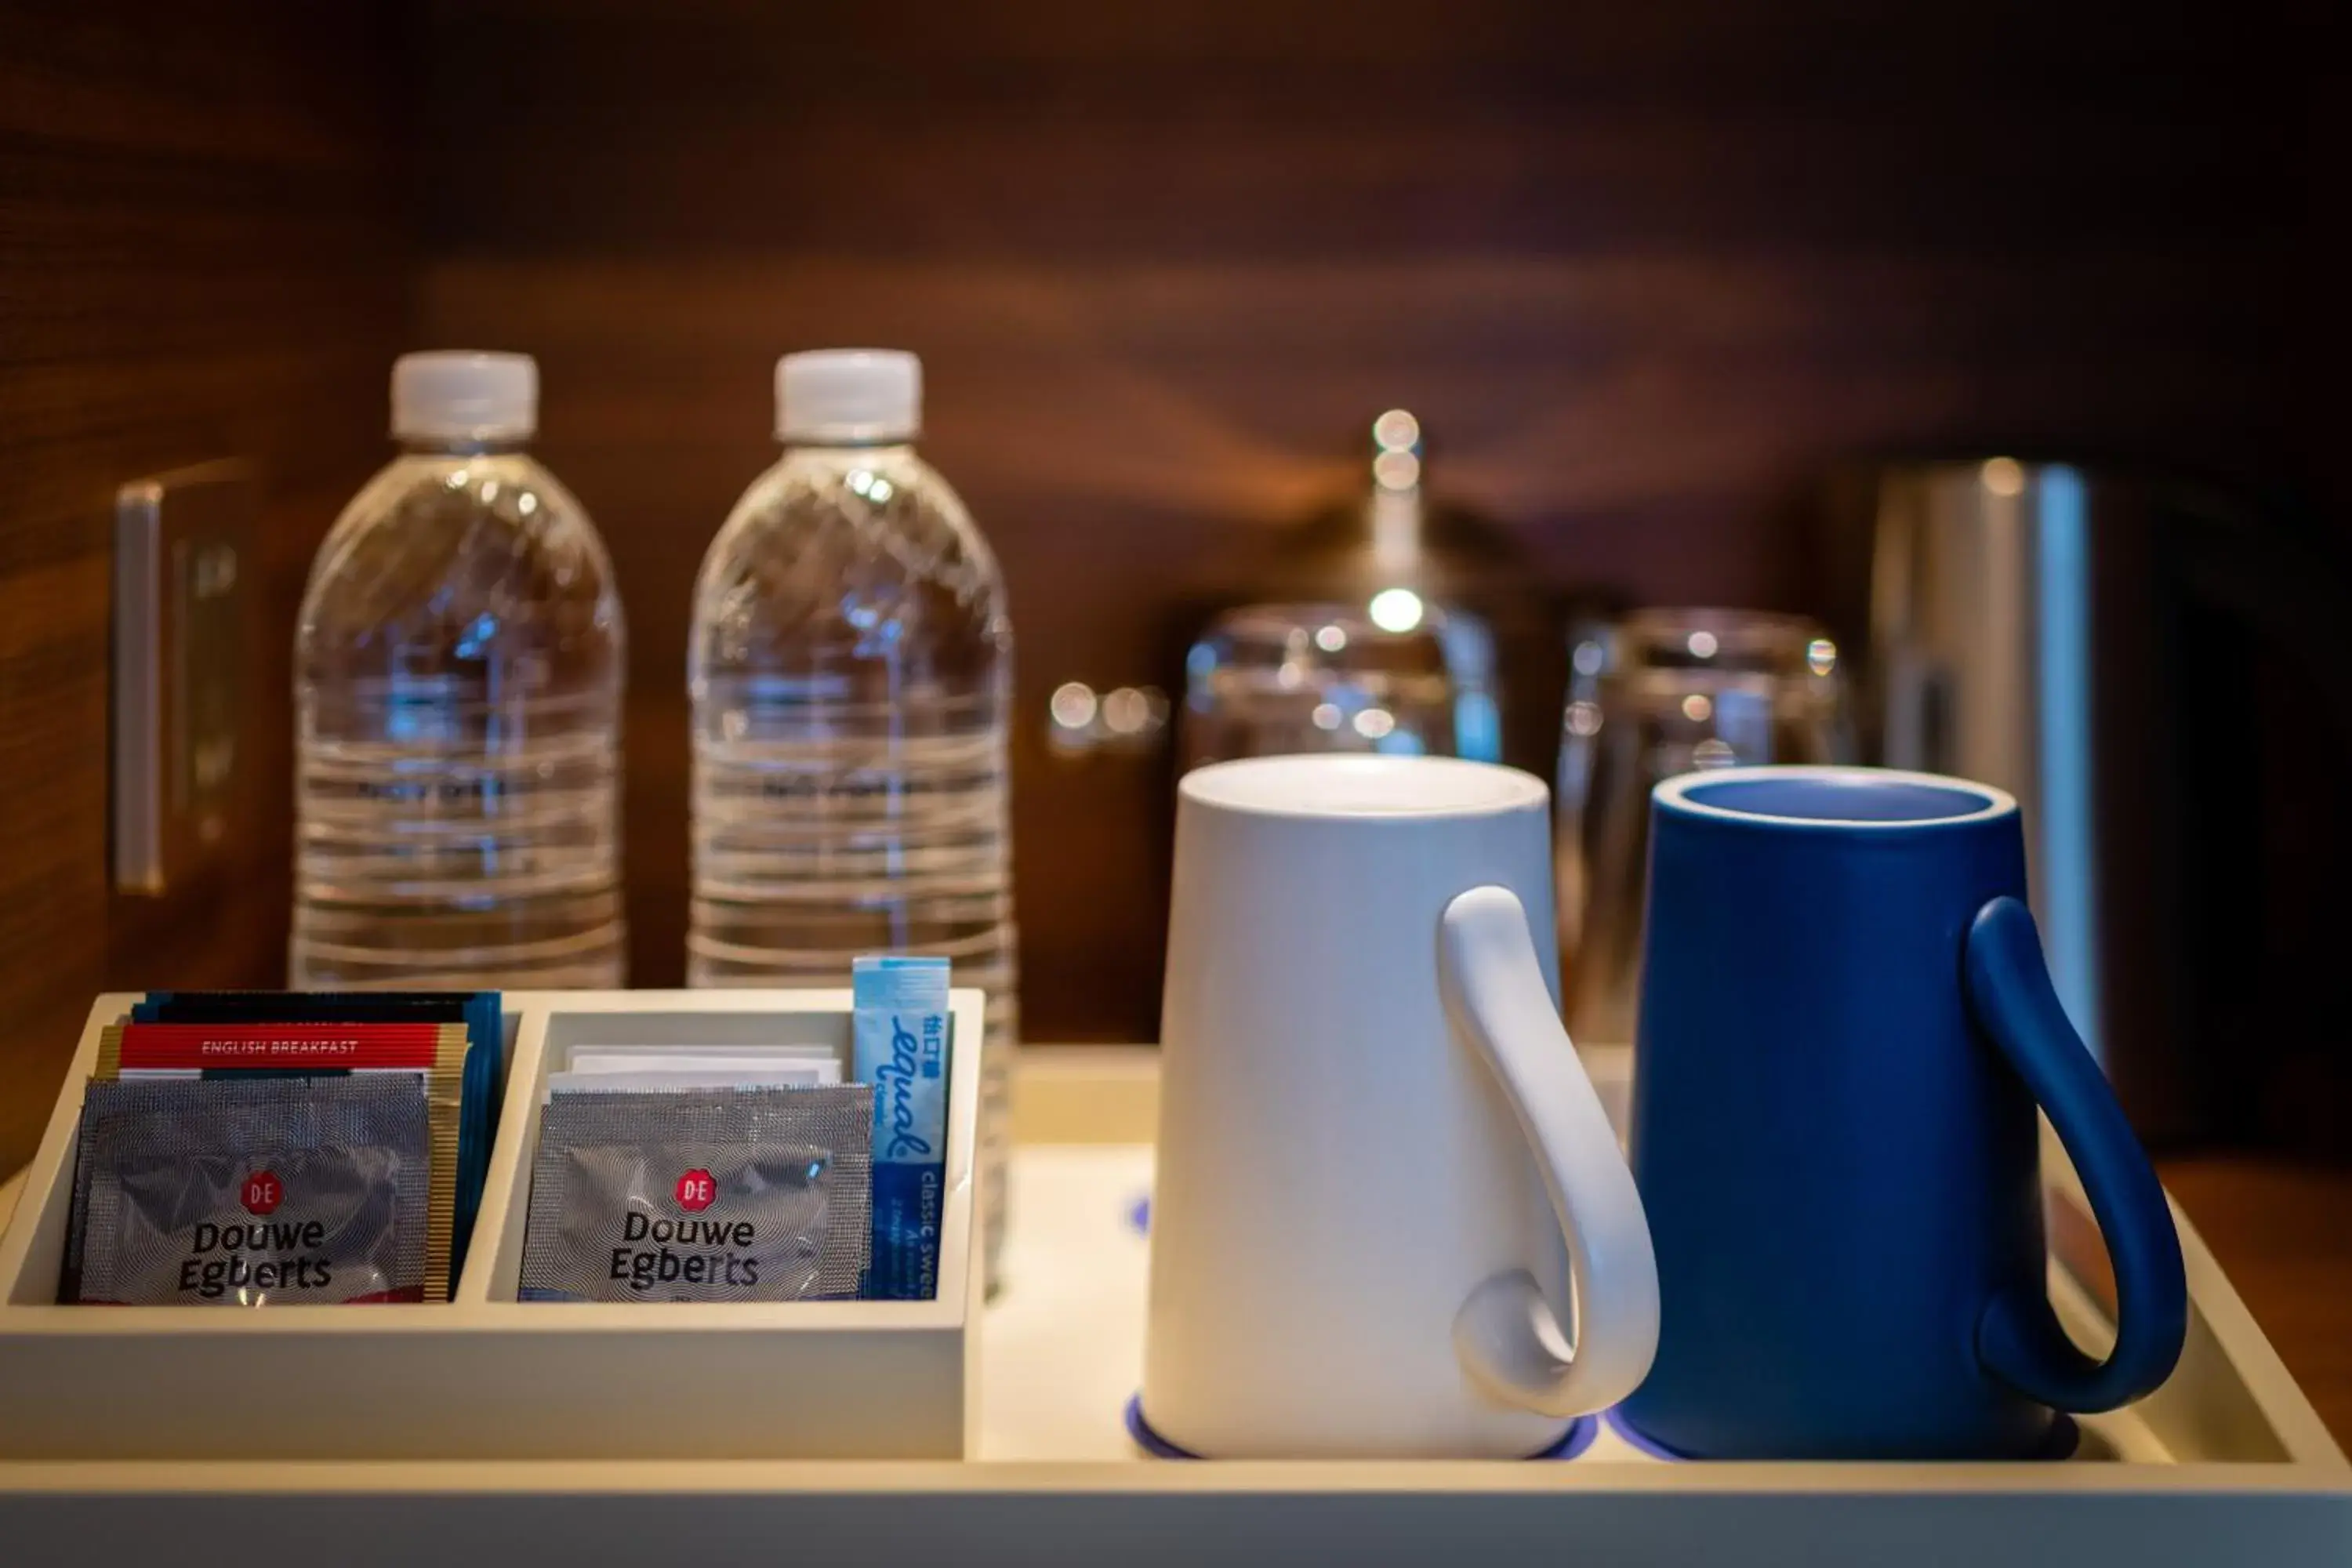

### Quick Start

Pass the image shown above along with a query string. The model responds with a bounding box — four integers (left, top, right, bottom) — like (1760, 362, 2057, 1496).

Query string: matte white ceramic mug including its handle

(1143, 755, 1658, 1457)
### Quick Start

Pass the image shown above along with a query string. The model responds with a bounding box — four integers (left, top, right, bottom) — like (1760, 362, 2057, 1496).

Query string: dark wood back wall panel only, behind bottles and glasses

(419, 0, 2319, 1039)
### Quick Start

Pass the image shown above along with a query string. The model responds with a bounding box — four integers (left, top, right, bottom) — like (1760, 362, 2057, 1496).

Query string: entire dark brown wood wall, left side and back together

(0, 0, 2347, 1163)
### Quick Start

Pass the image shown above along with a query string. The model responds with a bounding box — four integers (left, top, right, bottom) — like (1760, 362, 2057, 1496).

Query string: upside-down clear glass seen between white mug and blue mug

(1555, 609, 1851, 1044)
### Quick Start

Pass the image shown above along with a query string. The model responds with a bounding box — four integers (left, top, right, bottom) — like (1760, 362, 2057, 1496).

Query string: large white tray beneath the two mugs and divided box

(0, 1034, 2352, 1568)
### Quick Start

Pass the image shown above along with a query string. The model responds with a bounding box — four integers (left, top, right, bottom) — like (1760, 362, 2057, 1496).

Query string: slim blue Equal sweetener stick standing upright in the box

(849, 956, 950, 1300)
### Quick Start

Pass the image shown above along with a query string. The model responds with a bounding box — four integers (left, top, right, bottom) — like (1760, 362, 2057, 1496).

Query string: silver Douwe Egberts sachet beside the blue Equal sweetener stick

(515, 1083, 873, 1302)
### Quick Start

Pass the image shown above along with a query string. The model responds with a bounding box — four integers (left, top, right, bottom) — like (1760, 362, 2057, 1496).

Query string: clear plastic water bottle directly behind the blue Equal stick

(687, 350, 1018, 1286)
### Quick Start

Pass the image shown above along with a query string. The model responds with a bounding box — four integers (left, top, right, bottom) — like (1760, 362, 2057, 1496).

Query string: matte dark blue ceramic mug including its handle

(1621, 767, 2187, 1460)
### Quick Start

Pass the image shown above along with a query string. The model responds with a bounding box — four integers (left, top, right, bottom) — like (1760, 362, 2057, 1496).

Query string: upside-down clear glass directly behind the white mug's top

(1183, 595, 1458, 771)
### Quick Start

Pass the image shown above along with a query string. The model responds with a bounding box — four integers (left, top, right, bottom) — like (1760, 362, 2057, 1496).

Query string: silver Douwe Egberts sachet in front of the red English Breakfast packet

(71, 1074, 435, 1307)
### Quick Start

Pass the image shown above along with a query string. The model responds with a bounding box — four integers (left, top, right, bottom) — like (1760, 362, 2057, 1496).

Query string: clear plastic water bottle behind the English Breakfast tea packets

(289, 353, 623, 987)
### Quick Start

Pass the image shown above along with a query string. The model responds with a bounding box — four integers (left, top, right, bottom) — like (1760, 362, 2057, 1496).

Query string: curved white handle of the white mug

(1437, 886, 1658, 1415)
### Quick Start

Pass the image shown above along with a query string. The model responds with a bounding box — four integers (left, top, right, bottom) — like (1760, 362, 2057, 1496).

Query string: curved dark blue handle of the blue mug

(1966, 898, 2190, 1415)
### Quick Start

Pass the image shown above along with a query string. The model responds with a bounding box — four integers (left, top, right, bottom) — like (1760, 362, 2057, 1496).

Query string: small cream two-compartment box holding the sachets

(0, 989, 981, 1467)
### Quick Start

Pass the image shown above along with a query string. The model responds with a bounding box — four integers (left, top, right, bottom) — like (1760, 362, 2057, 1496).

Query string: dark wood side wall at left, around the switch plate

(0, 0, 407, 1171)
